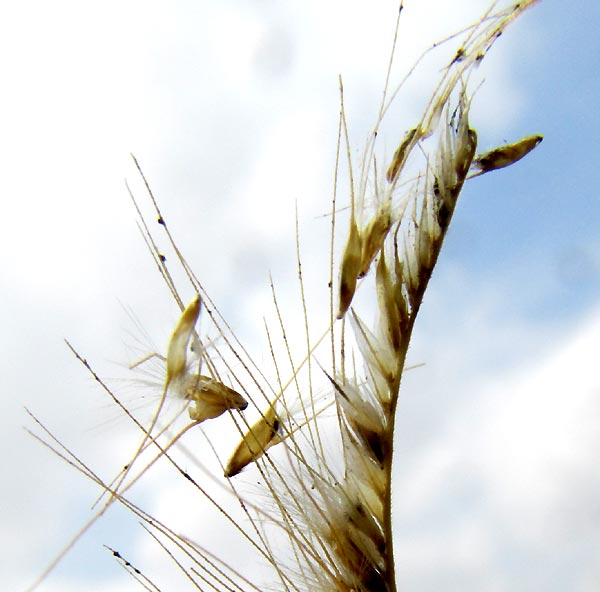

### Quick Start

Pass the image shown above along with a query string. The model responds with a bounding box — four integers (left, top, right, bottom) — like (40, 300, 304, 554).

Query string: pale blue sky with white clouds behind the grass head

(0, 0, 600, 592)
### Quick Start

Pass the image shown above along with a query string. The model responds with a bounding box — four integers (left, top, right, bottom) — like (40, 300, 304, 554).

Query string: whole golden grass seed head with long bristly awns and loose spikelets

(27, 0, 541, 592)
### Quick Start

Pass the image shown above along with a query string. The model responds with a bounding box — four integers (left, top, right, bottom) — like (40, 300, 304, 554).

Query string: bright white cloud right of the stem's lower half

(395, 311, 600, 591)
